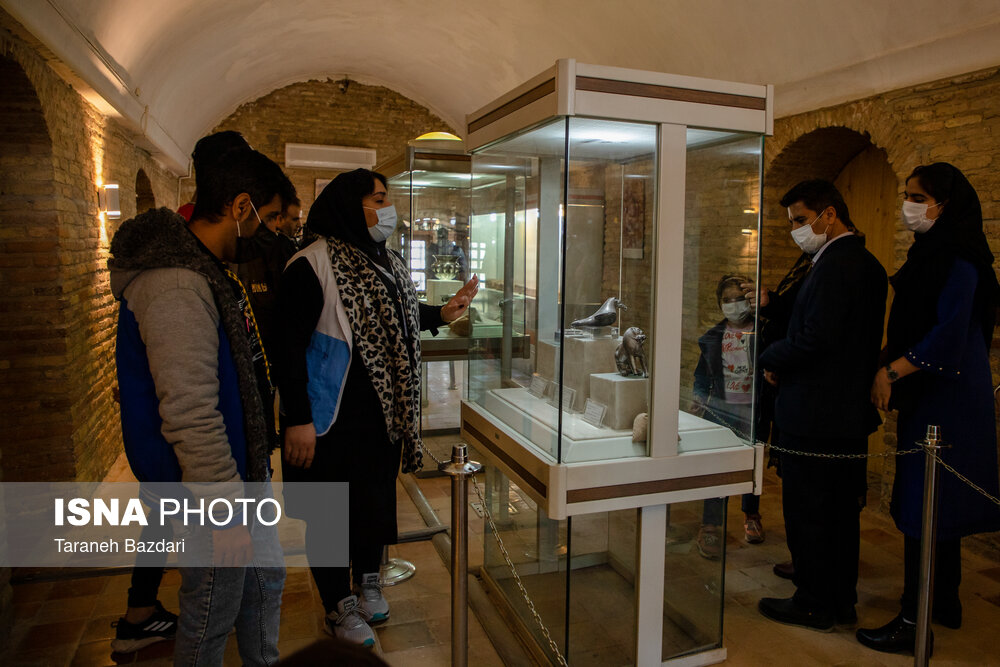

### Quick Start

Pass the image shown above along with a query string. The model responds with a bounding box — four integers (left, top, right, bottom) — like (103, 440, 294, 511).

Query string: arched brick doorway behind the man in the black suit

(761, 127, 899, 486)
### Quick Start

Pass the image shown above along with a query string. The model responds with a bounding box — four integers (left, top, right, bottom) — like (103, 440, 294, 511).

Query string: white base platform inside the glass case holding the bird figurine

(483, 387, 746, 463)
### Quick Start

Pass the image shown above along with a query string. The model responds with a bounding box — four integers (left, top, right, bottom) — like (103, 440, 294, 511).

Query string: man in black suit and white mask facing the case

(758, 180, 887, 631)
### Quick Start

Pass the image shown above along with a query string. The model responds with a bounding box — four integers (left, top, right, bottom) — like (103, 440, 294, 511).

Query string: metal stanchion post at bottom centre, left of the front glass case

(438, 445, 483, 667)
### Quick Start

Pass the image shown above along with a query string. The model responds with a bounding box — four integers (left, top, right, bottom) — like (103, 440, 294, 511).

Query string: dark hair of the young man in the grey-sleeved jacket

(191, 148, 290, 222)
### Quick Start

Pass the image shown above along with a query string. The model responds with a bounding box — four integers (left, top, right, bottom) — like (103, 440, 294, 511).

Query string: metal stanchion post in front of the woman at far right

(913, 425, 943, 667)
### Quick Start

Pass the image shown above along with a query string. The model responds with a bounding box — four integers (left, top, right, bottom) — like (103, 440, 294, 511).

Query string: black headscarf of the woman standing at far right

(887, 162, 1000, 360)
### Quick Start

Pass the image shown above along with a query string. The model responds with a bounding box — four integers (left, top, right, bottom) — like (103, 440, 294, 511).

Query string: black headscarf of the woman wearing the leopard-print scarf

(306, 169, 389, 269)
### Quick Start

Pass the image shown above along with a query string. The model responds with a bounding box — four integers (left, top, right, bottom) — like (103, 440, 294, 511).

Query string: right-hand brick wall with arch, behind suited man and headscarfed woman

(762, 68, 1000, 550)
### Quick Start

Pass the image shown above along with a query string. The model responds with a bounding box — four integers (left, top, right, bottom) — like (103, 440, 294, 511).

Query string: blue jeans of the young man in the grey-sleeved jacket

(174, 488, 285, 667)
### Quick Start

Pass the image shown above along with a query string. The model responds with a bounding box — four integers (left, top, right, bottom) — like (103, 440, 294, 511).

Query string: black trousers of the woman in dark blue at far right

(901, 536, 962, 622)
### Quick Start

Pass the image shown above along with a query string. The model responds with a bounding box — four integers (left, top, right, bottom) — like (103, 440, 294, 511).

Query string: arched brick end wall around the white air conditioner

(187, 79, 455, 217)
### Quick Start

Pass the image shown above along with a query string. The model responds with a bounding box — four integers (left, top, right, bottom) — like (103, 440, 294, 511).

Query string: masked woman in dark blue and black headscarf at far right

(857, 162, 1000, 652)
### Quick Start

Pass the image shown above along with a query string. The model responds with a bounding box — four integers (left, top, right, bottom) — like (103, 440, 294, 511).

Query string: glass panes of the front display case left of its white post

(469, 117, 657, 463)
